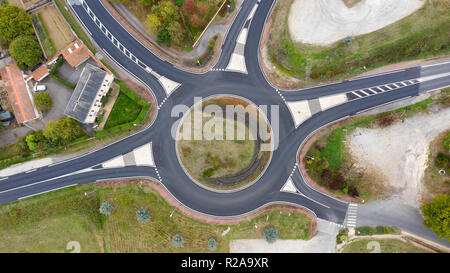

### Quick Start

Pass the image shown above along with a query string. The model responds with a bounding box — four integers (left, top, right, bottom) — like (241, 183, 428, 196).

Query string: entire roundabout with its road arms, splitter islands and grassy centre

(0, 0, 450, 243)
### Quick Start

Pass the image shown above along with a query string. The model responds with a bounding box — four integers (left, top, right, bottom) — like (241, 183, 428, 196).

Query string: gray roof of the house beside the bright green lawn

(64, 63, 108, 122)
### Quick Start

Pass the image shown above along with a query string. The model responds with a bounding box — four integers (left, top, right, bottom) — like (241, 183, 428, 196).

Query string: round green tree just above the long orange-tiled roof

(9, 35, 42, 66)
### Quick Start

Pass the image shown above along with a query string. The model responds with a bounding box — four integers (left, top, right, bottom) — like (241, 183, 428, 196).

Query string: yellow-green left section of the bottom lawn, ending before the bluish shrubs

(0, 186, 101, 252)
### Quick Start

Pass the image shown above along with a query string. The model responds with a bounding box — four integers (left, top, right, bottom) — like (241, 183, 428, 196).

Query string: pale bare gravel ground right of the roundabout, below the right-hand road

(346, 108, 450, 207)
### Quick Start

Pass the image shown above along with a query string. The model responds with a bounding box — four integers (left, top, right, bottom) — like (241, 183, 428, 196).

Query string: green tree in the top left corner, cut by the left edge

(0, 5, 34, 43)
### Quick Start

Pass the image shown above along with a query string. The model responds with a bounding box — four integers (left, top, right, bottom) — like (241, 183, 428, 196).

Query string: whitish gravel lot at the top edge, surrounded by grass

(288, 0, 425, 46)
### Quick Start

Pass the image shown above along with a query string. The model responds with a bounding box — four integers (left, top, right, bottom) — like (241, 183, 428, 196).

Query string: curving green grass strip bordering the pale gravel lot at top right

(268, 0, 450, 86)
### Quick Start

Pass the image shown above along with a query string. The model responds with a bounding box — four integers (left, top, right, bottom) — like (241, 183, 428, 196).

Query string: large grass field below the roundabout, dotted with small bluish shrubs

(0, 184, 311, 252)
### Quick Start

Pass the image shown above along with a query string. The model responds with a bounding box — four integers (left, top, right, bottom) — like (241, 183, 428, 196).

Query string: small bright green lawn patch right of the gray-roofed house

(105, 92, 142, 129)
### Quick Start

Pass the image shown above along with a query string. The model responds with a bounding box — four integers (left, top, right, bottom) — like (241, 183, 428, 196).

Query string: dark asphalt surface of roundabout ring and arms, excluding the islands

(0, 0, 450, 245)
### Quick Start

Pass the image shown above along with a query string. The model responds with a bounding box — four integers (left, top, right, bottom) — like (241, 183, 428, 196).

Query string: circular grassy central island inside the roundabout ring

(176, 95, 273, 192)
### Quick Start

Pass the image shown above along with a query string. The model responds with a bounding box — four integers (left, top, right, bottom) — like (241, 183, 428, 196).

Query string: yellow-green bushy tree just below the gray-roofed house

(44, 117, 85, 145)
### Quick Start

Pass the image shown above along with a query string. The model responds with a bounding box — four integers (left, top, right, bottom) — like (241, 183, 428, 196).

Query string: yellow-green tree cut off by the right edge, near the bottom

(421, 194, 450, 240)
